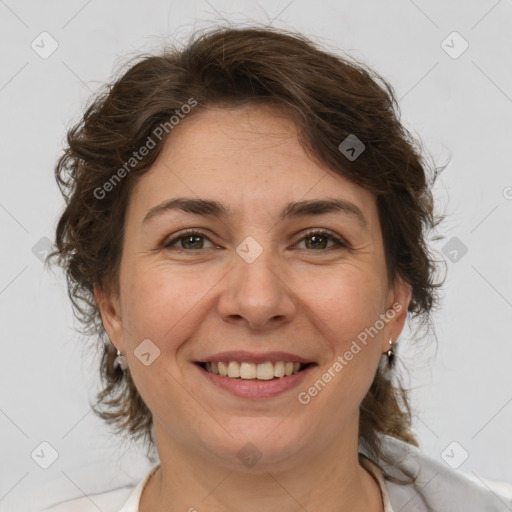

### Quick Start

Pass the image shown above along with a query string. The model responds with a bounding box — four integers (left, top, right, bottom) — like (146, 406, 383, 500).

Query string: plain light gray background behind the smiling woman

(0, 0, 512, 512)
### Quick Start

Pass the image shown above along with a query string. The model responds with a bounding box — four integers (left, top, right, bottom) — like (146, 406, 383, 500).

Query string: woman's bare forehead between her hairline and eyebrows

(126, 106, 375, 228)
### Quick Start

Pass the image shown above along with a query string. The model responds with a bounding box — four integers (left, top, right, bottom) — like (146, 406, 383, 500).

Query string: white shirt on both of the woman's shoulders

(43, 436, 512, 512)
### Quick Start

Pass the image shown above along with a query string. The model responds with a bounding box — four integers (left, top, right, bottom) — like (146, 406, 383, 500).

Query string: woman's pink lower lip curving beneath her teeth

(195, 364, 315, 398)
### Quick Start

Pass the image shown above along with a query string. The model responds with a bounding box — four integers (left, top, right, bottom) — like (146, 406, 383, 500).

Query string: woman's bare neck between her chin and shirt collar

(139, 416, 384, 512)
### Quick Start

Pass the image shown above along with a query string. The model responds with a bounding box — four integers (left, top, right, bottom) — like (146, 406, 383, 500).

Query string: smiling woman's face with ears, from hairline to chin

(96, 107, 410, 467)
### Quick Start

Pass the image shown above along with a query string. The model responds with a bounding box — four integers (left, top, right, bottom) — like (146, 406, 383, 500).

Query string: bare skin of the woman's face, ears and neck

(95, 106, 410, 512)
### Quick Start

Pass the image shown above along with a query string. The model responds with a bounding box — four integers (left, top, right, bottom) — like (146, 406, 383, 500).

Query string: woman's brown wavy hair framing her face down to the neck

(49, 27, 443, 483)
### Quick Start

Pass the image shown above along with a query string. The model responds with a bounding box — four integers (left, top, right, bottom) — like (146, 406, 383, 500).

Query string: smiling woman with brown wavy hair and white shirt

(46, 28, 510, 512)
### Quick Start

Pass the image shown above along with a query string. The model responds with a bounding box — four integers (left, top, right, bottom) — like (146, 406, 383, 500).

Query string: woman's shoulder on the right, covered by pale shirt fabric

(372, 436, 512, 512)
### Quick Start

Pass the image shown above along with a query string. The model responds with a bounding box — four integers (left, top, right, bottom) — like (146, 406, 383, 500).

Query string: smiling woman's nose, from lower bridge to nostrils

(218, 251, 296, 330)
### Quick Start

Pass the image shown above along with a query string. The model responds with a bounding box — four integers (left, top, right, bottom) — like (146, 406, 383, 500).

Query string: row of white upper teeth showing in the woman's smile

(205, 361, 300, 380)
